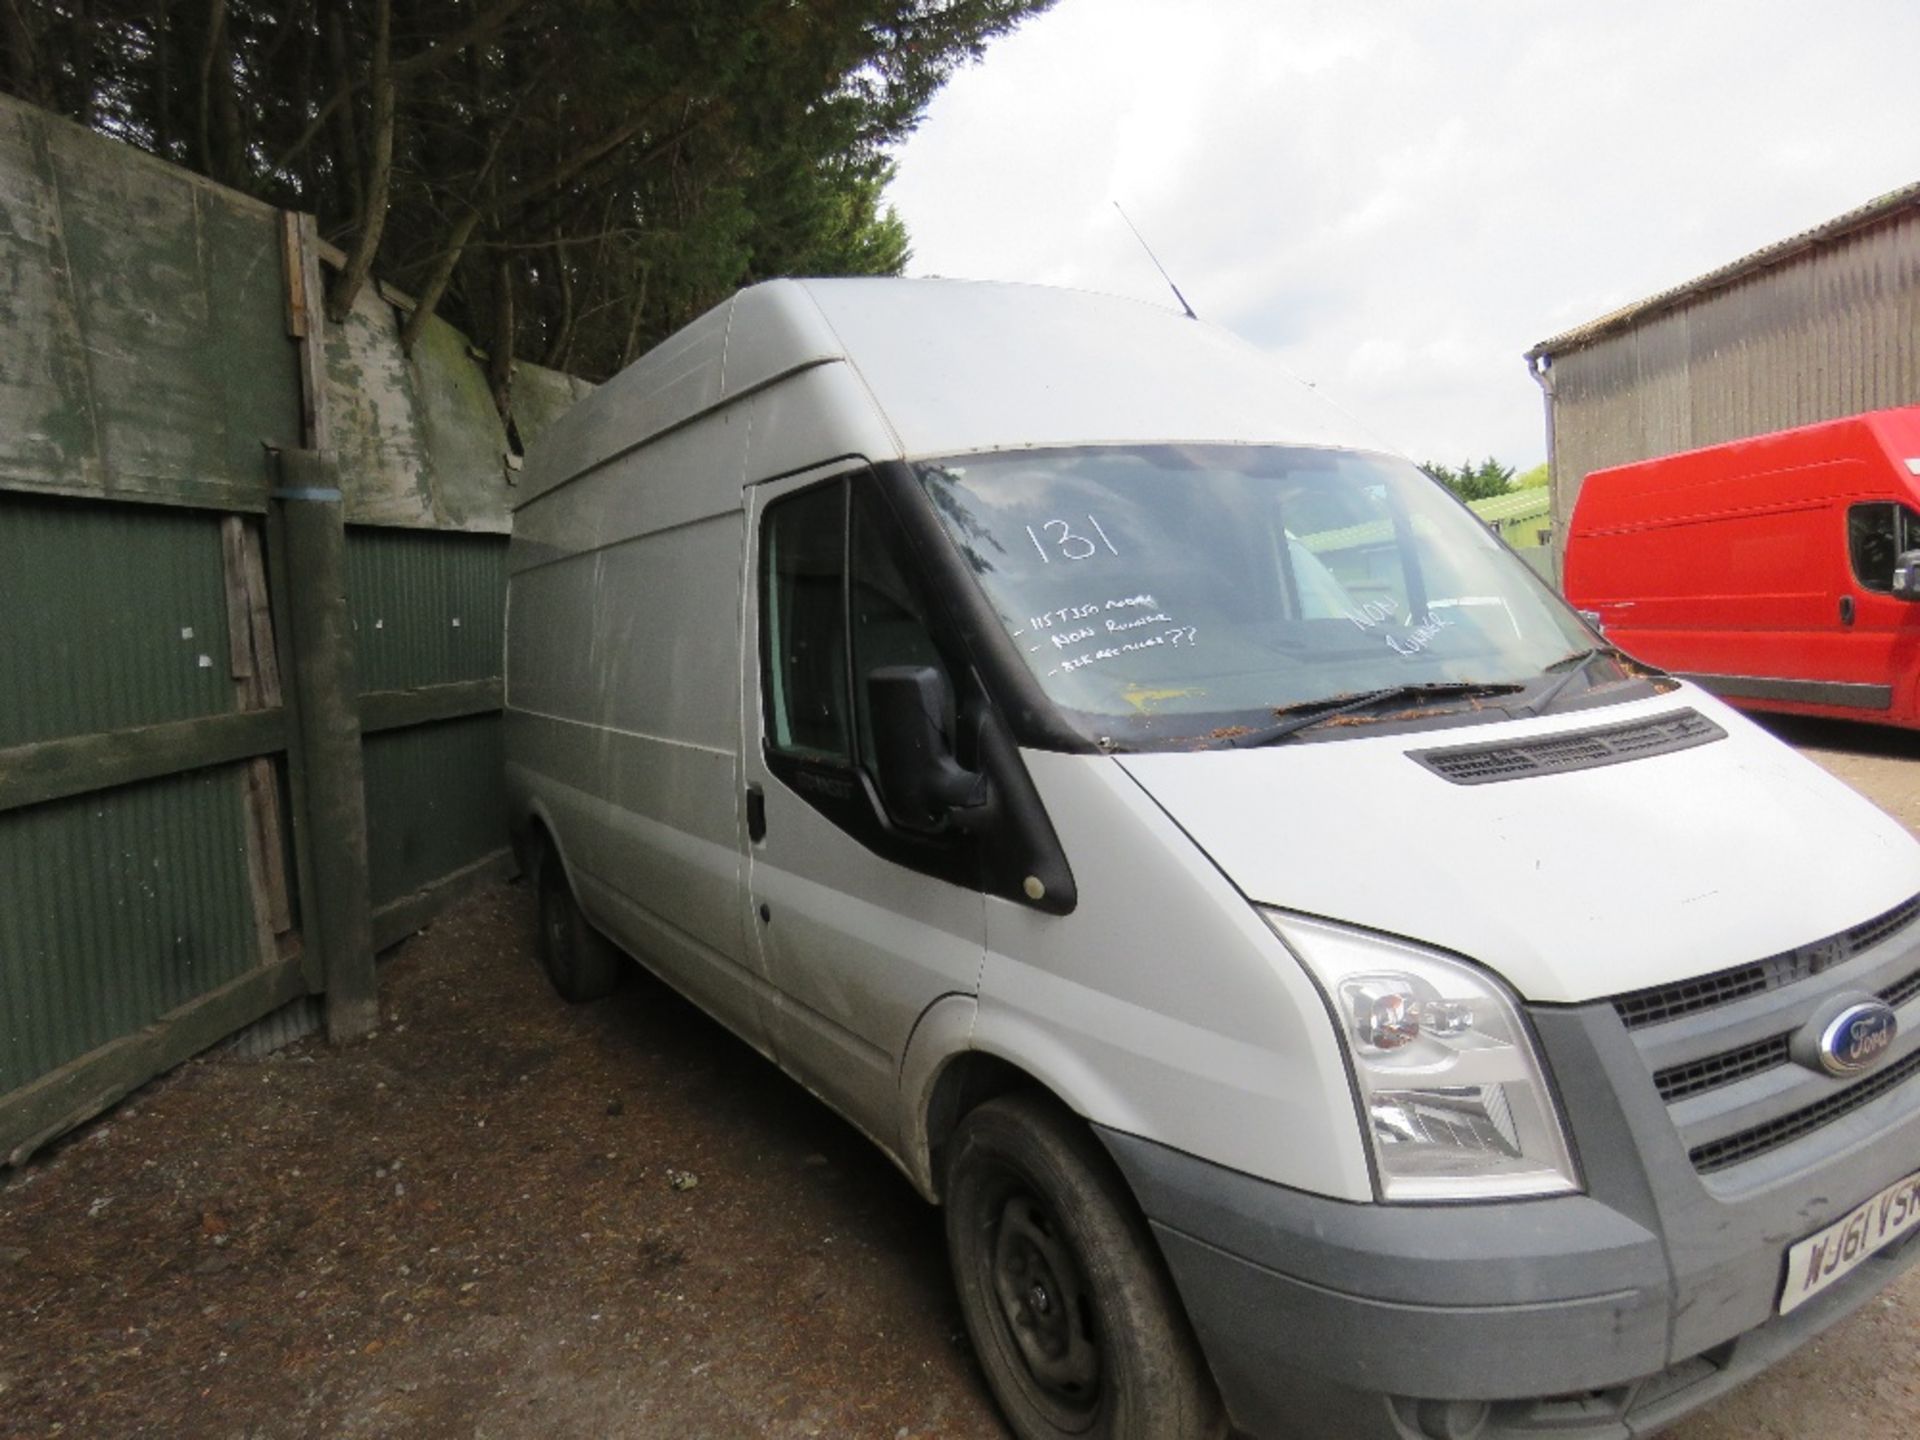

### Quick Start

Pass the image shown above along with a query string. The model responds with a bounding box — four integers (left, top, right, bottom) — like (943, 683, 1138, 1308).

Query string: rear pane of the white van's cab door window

(760, 480, 852, 760)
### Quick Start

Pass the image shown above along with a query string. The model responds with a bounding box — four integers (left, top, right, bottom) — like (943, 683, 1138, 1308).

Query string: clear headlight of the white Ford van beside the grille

(1261, 910, 1580, 1200)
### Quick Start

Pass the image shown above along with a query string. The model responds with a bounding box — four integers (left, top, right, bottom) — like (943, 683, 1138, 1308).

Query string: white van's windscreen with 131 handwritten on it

(918, 445, 1597, 743)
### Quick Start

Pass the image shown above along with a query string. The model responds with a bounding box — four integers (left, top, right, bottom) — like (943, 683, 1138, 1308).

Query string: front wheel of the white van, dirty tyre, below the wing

(947, 1094, 1225, 1440)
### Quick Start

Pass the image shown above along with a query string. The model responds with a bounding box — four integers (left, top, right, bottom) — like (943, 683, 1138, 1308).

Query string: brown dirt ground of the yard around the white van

(0, 726, 1920, 1440)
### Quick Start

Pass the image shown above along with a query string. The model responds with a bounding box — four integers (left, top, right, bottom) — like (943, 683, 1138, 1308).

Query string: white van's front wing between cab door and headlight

(973, 751, 1373, 1200)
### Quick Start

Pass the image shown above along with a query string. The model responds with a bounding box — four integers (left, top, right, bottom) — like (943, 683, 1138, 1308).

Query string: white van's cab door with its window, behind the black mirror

(741, 463, 985, 1148)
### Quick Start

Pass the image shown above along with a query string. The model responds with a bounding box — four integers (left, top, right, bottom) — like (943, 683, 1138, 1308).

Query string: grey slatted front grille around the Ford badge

(1613, 897, 1920, 1175)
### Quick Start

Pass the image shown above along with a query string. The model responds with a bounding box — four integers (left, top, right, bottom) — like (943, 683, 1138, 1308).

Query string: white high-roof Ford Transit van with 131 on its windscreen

(507, 280, 1920, 1440)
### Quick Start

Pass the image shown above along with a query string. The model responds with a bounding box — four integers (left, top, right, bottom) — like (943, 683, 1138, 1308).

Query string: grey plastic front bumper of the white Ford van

(1100, 1006, 1920, 1440)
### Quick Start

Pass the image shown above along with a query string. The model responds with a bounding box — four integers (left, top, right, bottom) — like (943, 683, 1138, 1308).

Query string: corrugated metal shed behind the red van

(1526, 184, 1920, 572)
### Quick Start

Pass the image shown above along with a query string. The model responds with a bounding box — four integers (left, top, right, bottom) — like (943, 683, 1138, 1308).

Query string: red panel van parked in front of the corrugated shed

(1563, 405, 1920, 728)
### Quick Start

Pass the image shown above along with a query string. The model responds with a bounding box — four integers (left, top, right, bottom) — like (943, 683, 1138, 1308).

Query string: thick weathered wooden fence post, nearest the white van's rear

(273, 449, 380, 1043)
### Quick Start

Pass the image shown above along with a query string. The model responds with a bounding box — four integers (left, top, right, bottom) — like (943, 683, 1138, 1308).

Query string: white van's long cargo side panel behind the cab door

(507, 401, 764, 1043)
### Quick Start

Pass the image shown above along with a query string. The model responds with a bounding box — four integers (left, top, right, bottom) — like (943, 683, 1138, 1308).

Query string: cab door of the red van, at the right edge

(1832, 499, 1920, 724)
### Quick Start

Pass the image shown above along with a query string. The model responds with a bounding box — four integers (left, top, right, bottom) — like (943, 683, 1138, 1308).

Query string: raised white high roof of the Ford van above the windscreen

(518, 278, 1390, 505)
